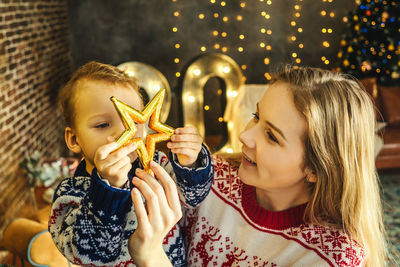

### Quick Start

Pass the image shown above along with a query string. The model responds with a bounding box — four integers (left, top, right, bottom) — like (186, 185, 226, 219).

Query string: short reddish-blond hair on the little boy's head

(58, 61, 141, 126)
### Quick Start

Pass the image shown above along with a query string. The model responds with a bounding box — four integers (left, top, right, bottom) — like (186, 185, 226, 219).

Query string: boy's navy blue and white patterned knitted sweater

(49, 146, 213, 266)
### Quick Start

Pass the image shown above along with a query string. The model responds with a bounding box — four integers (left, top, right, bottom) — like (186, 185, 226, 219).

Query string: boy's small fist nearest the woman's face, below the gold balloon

(167, 126, 203, 167)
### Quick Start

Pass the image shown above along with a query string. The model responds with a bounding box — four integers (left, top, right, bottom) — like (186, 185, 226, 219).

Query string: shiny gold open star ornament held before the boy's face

(111, 89, 174, 172)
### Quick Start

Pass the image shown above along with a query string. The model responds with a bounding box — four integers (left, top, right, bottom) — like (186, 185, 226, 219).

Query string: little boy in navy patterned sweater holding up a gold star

(49, 62, 213, 266)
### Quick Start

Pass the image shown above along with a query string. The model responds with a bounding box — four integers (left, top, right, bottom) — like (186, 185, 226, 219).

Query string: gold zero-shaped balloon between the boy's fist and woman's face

(182, 53, 244, 153)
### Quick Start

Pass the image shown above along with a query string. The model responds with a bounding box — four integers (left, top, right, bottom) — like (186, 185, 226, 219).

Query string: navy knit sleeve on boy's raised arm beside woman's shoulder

(170, 144, 214, 207)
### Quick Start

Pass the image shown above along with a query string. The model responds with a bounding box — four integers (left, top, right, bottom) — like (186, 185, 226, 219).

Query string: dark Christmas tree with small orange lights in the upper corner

(338, 0, 400, 86)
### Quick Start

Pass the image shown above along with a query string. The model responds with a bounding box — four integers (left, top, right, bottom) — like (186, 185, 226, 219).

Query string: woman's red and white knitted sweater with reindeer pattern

(185, 157, 365, 267)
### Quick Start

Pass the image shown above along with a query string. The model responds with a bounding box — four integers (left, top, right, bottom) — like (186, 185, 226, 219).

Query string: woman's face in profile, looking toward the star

(239, 81, 307, 193)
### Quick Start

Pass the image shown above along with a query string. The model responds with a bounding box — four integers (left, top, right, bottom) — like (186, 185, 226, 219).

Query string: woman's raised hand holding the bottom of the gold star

(128, 161, 182, 266)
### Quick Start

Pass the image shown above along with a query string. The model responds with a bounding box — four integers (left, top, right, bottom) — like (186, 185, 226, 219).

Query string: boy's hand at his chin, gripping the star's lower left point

(94, 139, 137, 188)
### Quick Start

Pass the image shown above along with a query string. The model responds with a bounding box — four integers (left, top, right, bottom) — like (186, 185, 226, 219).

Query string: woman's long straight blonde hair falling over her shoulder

(272, 66, 387, 266)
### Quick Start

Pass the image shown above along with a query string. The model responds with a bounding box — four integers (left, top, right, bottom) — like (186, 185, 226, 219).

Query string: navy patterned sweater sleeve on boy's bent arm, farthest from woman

(49, 169, 132, 265)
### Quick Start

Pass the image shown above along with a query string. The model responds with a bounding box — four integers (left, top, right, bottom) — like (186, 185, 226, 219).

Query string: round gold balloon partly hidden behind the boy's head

(117, 61, 171, 122)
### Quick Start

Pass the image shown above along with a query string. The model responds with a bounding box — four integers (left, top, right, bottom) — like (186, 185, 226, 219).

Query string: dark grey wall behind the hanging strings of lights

(68, 0, 355, 129)
